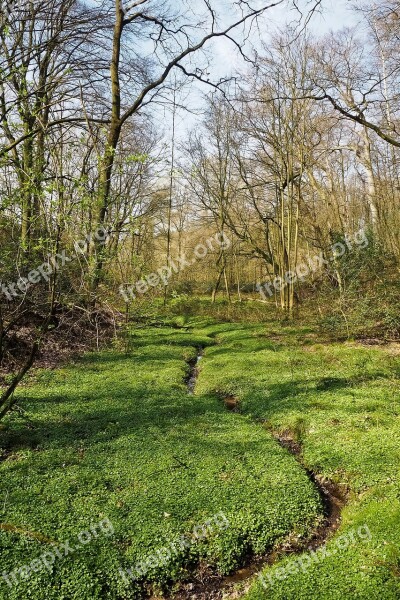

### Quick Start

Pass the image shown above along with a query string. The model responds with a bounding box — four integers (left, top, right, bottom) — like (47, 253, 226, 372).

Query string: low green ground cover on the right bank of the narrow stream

(198, 324, 400, 600)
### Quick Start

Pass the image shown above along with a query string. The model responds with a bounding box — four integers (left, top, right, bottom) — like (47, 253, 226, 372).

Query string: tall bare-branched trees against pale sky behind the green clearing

(0, 0, 400, 415)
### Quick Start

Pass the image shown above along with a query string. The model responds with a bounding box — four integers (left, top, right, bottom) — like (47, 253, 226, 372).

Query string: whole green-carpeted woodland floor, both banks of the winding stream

(0, 318, 400, 600)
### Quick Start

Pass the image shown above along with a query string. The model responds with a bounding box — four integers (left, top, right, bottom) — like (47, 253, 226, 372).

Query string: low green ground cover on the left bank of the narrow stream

(0, 323, 321, 600)
